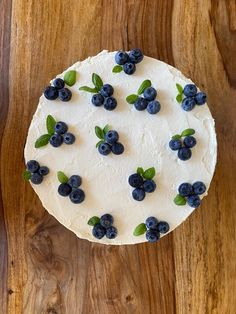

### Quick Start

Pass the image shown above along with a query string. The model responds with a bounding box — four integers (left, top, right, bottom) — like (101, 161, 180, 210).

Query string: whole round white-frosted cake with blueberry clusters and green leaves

(24, 49, 217, 245)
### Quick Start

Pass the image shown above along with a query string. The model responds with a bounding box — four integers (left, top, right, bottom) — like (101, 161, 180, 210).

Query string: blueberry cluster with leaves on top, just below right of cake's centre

(128, 167, 156, 201)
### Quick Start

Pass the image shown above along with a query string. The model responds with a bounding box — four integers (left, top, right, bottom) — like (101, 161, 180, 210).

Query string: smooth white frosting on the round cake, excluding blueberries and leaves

(25, 51, 217, 244)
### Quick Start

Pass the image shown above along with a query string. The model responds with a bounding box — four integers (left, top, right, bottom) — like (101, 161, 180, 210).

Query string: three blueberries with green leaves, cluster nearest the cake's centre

(95, 125, 124, 156)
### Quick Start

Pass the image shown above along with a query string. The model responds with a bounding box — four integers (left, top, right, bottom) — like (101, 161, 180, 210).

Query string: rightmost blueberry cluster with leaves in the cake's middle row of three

(169, 129, 197, 161)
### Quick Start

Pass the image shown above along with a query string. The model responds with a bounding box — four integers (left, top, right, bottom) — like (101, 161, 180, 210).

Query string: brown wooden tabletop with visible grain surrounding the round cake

(0, 0, 236, 314)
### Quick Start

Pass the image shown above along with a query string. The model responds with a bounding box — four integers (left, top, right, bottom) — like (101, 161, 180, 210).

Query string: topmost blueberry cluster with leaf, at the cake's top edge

(112, 49, 143, 75)
